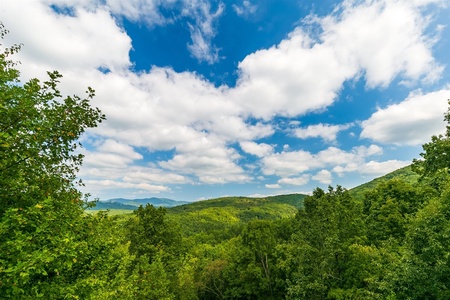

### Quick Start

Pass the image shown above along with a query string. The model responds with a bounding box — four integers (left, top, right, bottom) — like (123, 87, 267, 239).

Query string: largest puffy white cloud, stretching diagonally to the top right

(231, 0, 442, 119)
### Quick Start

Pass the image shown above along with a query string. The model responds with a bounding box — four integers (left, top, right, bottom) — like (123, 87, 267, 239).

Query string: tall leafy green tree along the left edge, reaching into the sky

(0, 23, 119, 299)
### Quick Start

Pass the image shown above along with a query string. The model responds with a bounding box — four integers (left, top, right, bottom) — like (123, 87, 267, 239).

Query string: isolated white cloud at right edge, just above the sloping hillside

(361, 89, 450, 145)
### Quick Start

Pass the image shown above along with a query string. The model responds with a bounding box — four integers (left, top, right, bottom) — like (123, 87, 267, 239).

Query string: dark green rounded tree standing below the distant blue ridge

(127, 204, 184, 299)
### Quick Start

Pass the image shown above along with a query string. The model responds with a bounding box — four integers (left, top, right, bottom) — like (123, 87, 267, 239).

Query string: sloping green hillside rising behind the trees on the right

(350, 165, 420, 200)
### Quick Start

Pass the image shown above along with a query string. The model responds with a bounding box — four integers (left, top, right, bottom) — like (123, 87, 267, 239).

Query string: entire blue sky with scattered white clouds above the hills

(0, 0, 450, 201)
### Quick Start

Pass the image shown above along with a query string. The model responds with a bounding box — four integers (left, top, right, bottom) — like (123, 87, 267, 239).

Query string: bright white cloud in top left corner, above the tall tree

(0, 1, 131, 78)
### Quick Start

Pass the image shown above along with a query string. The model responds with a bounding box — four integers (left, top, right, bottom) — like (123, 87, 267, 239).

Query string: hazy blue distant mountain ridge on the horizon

(92, 197, 190, 210)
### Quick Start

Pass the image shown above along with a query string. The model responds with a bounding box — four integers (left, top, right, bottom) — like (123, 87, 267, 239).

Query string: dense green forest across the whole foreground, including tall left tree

(0, 24, 450, 300)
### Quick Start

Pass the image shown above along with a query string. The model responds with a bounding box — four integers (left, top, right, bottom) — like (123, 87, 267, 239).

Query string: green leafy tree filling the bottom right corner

(386, 188, 450, 299)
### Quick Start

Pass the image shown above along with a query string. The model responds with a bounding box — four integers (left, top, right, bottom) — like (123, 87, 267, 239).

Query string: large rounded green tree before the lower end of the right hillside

(285, 186, 364, 299)
